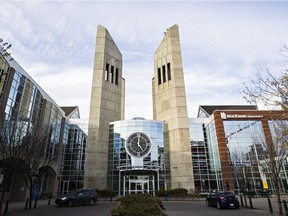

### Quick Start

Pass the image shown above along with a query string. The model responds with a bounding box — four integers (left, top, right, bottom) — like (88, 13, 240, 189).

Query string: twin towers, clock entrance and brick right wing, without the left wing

(84, 25, 287, 195)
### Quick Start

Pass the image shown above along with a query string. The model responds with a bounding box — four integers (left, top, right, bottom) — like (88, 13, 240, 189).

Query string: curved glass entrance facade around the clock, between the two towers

(108, 118, 170, 195)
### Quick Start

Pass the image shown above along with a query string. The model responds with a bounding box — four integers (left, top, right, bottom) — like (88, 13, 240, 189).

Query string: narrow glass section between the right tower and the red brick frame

(189, 118, 223, 193)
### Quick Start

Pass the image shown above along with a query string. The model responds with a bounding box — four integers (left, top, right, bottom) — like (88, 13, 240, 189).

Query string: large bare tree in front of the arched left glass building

(0, 118, 59, 209)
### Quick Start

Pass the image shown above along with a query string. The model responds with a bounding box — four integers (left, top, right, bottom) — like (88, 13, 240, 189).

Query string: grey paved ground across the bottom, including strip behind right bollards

(3, 197, 288, 216)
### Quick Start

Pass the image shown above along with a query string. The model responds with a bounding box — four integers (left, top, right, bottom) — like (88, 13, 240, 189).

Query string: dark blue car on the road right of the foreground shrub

(206, 192, 240, 209)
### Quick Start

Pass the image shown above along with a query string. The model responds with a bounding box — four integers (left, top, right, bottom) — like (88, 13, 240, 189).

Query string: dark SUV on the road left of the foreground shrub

(55, 189, 98, 207)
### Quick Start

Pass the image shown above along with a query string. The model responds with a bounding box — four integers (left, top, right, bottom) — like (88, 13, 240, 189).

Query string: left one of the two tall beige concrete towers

(84, 26, 125, 189)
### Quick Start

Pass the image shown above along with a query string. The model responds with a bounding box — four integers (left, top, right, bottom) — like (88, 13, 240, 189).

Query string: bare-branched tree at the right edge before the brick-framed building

(242, 45, 288, 215)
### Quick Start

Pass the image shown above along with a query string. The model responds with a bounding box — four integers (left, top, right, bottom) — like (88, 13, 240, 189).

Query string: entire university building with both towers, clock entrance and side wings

(0, 25, 288, 201)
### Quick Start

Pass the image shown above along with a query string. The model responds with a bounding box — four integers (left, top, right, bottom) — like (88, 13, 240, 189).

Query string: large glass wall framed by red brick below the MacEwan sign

(223, 120, 265, 195)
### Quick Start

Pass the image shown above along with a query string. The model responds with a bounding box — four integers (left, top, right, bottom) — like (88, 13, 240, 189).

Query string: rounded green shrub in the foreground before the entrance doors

(111, 194, 165, 216)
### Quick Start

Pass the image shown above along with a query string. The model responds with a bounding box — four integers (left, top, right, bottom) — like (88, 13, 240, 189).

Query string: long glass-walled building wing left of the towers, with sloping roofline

(0, 41, 87, 201)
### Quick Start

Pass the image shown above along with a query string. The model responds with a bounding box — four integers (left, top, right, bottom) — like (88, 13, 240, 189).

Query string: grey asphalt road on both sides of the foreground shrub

(8, 200, 273, 216)
